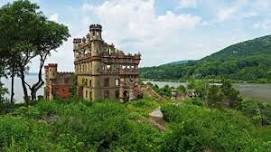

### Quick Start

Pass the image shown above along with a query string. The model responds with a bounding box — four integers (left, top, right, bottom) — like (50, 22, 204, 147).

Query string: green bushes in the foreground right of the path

(161, 104, 270, 152)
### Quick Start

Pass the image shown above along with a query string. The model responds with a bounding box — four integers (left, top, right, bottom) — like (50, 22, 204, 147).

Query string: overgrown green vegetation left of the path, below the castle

(0, 101, 163, 152)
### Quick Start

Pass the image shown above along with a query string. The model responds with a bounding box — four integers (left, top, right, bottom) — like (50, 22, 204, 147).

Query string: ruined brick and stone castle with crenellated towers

(45, 24, 141, 101)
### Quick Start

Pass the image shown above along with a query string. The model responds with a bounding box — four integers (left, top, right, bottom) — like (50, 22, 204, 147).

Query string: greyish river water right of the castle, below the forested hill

(145, 81, 271, 101)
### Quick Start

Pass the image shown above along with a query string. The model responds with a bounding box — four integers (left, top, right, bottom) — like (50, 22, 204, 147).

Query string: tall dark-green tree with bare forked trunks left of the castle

(0, 0, 70, 102)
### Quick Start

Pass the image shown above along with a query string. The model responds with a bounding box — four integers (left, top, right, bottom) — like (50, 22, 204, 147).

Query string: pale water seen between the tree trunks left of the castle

(1, 75, 43, 103)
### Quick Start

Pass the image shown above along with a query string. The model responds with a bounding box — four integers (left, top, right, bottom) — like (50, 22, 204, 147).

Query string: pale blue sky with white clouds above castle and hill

(0, 0, 271, 71)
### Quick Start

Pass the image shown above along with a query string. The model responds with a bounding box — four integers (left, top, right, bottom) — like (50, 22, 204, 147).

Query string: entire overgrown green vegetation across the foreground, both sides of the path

(0, 99, 271, 152)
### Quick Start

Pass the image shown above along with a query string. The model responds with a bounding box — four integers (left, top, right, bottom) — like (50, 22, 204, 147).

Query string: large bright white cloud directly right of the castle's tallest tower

(82, 0, 201, 65)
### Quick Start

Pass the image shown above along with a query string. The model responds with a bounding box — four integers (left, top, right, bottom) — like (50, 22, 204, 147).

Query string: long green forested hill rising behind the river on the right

(140, 35, 271, 82)
